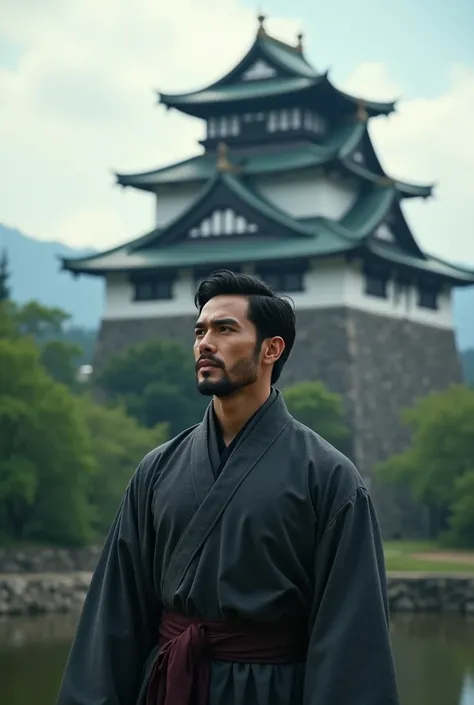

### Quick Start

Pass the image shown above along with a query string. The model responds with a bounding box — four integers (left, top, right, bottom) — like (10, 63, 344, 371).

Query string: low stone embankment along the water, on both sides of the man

(0, 548, 474, 615)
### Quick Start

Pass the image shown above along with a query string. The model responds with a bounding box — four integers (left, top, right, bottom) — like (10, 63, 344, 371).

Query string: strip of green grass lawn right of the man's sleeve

(384, 541, 474, 574)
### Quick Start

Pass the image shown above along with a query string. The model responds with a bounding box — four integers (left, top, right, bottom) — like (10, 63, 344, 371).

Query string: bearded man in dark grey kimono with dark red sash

(58, 271, 398, 705)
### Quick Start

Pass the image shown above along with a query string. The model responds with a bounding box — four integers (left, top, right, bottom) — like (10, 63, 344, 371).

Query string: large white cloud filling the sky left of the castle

(0, 0, 298, 247)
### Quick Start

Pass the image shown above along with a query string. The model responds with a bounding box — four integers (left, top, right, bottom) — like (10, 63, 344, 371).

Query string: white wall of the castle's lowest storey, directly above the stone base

(103, 259, 453, 329)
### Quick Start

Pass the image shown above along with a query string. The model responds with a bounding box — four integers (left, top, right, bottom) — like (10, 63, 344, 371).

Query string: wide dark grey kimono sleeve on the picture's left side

(57, 459, 160, 705)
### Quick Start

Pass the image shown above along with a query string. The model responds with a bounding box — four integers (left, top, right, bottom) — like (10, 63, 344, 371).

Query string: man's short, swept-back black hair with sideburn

(194, 269, 296, 384)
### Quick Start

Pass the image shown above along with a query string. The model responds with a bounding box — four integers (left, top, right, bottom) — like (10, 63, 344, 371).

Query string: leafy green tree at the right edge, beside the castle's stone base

(376, 385, 474, 540)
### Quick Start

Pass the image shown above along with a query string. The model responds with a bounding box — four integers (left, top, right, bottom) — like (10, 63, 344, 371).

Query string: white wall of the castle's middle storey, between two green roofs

(252, 170, 357, 220)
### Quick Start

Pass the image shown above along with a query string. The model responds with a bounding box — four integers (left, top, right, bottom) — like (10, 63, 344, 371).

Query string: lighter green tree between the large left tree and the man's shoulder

(81, 396, 168, 536)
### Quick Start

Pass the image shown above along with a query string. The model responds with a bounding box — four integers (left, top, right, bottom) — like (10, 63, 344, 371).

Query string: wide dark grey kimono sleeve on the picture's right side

(304, 486, 399, 705)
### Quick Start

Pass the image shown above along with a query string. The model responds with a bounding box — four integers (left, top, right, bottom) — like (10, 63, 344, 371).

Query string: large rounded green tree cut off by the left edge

(0, 337, 93, 544)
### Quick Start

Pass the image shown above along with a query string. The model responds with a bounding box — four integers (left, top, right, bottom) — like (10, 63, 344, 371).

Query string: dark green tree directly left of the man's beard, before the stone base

(97, 340, 208, 436)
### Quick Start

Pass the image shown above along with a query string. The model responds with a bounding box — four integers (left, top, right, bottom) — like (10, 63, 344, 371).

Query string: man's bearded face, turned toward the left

(194, 296, 260, 397)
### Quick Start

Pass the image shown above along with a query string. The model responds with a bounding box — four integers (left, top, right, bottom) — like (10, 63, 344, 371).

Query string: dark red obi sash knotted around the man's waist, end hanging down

(146, 612, 307, 705)
